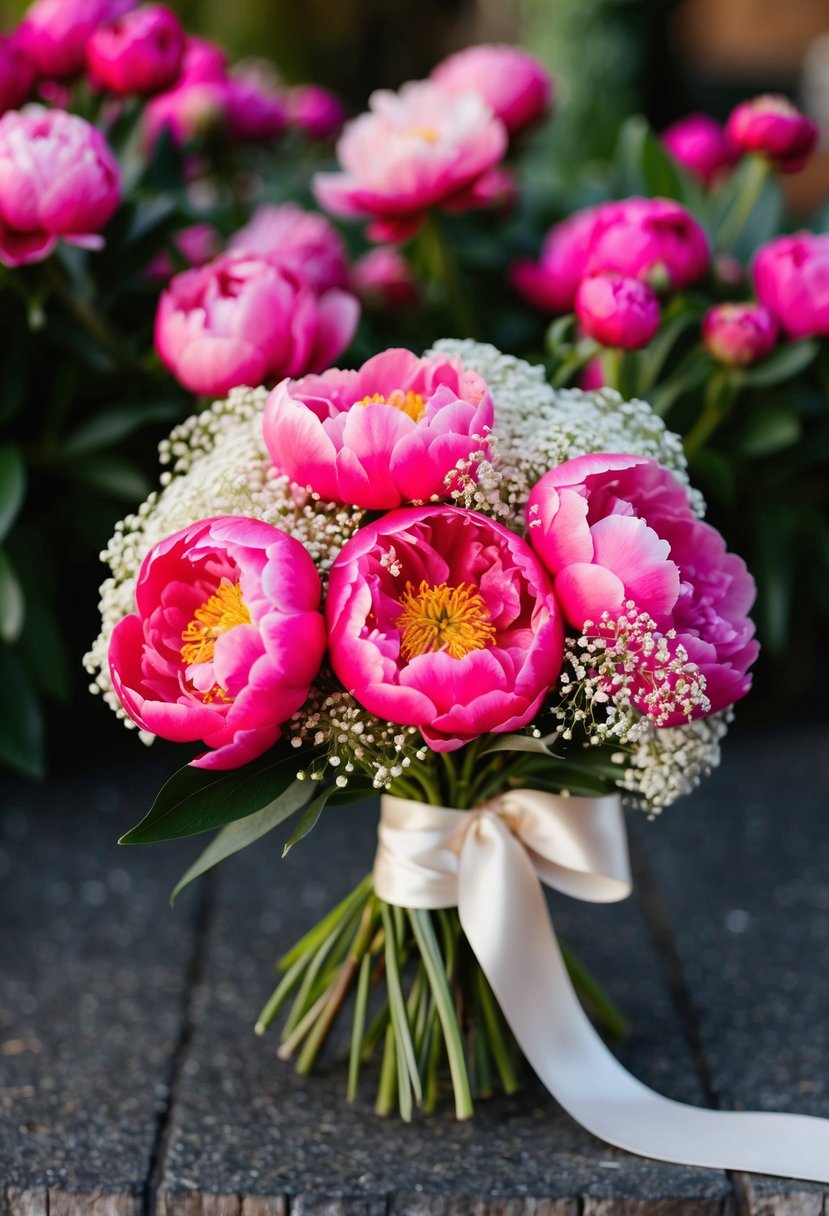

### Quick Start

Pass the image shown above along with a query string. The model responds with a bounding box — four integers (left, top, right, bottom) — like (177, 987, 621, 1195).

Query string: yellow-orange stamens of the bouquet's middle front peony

(395, 579, 495, 662)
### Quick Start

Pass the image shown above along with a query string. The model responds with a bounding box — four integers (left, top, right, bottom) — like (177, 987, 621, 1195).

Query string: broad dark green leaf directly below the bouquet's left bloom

(119, 748, 305, 844)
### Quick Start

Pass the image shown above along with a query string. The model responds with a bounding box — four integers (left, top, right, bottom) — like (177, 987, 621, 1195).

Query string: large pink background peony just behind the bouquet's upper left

(156, 253, 359, 396)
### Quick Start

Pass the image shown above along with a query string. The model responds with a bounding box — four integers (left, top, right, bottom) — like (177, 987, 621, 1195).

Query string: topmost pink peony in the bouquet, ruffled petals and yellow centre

(264, 350, 492, 511)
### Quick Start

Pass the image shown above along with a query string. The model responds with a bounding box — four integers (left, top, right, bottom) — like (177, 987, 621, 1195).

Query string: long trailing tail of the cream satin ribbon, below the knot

(458, 815, 829, 1182)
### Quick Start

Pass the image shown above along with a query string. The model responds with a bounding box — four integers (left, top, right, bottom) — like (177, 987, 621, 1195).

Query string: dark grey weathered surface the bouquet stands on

(0, 730, 829, 1216)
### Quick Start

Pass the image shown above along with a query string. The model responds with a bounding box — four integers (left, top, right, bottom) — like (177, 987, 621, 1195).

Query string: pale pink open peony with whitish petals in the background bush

(314, 80, 507, 241)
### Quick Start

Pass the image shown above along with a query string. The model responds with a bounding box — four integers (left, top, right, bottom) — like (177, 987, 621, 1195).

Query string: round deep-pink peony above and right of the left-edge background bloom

(86, 4, 185, 96)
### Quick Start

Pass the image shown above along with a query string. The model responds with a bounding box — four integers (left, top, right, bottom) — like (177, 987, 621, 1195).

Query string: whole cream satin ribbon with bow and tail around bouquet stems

(374, 790, 829, 1182)
